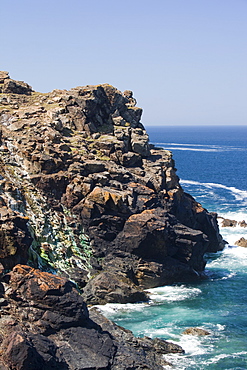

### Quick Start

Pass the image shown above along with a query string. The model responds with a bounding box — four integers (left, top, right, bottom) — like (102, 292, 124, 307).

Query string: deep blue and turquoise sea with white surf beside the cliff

(97, 126, 247, 370)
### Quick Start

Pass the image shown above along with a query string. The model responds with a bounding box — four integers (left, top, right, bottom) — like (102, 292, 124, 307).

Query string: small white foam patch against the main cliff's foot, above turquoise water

(147, 285, 201, 303)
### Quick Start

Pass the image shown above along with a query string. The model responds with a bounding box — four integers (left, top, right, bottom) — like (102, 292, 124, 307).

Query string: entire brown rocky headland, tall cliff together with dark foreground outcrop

(0, 72, 225, 369)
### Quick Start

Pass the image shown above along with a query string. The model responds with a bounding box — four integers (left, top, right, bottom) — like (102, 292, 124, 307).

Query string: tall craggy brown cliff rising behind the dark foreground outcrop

(0, 72, 224, 301)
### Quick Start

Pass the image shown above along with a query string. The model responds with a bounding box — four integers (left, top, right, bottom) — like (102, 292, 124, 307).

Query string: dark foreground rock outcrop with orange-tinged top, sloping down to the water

(0, 265, 184, 370)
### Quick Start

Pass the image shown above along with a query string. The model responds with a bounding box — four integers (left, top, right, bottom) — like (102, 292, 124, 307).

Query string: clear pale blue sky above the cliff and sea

(0, 0, 247, 125)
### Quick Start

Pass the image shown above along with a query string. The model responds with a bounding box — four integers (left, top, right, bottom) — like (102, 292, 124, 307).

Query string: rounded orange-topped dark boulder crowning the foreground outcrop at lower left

(6, 265, 88, 333)
